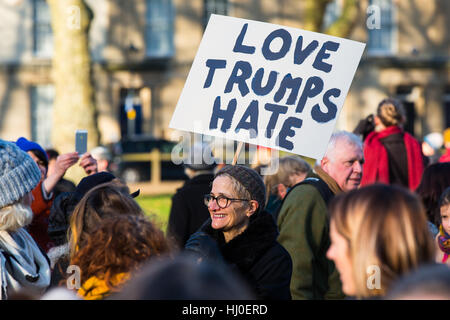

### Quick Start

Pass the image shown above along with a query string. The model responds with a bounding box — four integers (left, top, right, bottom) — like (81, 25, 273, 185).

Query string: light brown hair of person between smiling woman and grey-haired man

(264, 156, 311, 203)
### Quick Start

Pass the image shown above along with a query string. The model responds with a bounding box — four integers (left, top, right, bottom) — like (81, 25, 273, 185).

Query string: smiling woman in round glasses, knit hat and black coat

(185, 165, 292, 299)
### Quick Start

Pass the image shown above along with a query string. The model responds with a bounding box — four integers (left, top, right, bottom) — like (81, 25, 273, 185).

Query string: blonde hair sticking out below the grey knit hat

(0, 197, 33, 231)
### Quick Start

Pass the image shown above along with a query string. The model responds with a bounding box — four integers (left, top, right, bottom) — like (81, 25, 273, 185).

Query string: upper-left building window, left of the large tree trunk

(33, 0, 53, 58)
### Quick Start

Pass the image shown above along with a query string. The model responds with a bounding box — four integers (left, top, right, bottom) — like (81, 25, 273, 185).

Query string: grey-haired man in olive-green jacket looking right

(277, 131, 364, 299)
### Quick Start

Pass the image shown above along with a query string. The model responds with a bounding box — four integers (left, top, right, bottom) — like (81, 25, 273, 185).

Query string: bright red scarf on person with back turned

(361, 126, 423, 190)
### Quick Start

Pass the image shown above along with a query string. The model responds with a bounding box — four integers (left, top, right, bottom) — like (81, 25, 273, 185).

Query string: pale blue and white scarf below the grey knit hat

(0, 228, 50, 300)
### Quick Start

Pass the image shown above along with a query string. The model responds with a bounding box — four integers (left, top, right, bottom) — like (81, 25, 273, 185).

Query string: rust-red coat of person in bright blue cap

(27, 180, 54, 252)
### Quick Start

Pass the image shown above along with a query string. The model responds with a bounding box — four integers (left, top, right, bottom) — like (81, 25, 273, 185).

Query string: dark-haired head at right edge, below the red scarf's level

(416, 162, 450, 225)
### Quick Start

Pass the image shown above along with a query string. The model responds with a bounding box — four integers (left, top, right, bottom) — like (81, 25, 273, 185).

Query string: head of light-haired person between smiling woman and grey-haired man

(264, 156, 311, 202)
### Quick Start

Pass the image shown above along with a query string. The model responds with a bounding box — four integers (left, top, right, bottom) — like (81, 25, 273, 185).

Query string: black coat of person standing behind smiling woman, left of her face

(167, 173, 214, 248)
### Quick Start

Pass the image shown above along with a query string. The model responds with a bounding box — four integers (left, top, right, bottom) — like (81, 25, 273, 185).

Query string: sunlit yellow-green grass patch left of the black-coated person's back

(136, 194, 172, 232)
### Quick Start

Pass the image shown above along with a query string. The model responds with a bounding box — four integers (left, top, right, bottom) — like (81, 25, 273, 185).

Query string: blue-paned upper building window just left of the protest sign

(145, 0, 175, 58)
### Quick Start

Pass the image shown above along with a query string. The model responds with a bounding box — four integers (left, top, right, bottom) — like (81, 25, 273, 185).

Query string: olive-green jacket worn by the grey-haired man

(277, 168, 345, 299)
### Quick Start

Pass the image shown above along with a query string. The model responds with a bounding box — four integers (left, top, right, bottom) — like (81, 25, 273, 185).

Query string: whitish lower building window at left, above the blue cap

(31, 85, 55, 148)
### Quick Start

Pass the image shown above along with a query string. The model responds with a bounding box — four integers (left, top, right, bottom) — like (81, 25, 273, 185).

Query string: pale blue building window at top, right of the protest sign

(366, 0, 396, 55)
